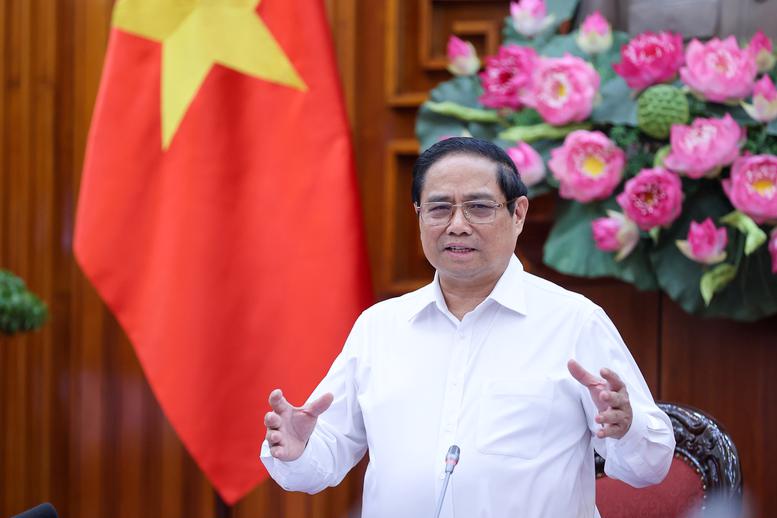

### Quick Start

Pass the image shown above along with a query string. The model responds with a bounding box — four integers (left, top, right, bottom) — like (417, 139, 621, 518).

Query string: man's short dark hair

(412, 137, 527, 213)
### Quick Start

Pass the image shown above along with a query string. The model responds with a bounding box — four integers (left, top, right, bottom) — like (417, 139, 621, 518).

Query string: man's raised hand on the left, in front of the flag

(264, 389, 334, 461)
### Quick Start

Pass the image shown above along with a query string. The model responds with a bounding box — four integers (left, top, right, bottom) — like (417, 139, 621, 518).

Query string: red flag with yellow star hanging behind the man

(74, 0, 372, 503)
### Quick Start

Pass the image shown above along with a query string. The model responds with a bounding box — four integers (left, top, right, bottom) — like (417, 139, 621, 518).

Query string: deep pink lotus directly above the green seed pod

(612, 32, 683, 90)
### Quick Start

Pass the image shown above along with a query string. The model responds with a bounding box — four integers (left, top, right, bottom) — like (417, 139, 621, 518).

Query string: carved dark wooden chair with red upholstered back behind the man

(596, 402, 742, 518)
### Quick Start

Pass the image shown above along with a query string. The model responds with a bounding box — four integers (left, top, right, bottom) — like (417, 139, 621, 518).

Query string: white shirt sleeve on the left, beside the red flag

(260, 317, 367, 494)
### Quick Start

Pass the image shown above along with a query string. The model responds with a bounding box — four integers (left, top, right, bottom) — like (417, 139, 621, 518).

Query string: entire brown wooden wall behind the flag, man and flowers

(0, 0, 777, 518)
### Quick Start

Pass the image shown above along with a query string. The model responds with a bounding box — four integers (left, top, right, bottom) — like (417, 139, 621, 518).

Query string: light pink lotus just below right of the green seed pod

(664, 114, 744, 178)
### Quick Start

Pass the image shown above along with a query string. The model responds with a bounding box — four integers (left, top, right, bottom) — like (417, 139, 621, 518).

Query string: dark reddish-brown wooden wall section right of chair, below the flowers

(661, 302, 777, 517)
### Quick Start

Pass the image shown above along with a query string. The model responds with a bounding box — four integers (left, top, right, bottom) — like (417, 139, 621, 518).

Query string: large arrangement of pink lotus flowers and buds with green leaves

(416, 0, 777, 321)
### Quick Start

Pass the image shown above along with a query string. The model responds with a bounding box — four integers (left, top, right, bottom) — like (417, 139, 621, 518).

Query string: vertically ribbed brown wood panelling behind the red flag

(0, 0, 363, 518)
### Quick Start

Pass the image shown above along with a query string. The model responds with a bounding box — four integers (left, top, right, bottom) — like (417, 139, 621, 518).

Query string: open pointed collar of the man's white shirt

(407, 255, 527, 320)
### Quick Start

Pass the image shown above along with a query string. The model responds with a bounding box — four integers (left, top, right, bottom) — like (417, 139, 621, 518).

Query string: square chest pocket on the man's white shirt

(475, 378, 554, 459)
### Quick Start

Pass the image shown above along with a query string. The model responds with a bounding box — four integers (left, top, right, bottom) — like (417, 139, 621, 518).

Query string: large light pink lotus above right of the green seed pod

(680, 36, 758, 102)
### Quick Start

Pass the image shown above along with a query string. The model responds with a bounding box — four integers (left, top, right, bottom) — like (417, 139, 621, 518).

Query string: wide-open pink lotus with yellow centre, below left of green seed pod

(548, 130, 626, 203)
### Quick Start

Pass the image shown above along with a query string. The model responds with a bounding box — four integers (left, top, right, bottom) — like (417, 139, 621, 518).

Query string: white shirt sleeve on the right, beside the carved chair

(576, 307, 675, 487)
